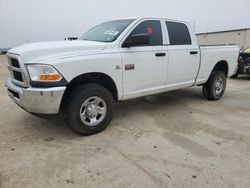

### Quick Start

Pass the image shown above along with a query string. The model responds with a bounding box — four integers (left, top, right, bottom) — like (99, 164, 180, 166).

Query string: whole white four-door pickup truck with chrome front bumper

(6, 18, 239, 135)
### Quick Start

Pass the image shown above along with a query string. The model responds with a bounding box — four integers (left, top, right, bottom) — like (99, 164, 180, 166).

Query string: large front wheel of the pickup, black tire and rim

(64, 84, 114, 136)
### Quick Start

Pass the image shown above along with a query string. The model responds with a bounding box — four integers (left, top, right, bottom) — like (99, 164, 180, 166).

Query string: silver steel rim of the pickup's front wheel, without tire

(80, 96, 107, 127)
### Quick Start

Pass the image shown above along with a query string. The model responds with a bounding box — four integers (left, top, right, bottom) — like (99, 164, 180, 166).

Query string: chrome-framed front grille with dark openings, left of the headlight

(8, 57, 28, 87)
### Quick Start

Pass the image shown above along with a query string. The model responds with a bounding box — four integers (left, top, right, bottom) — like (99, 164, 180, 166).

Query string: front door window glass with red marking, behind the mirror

(130, 20, 163, 46)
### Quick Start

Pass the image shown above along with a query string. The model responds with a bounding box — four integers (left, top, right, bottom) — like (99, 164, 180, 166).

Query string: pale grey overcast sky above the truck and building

(0, 0, 250, 48)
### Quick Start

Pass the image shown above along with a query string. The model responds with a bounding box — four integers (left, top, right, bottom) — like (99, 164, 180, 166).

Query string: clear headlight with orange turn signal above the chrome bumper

(27, 65, 63, 82)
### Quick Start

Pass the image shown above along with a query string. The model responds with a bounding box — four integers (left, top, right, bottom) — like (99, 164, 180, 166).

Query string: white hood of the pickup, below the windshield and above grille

(8, 40, 107, 64)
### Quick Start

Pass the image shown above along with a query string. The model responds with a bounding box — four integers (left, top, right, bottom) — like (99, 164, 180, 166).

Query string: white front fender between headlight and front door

(50, 53, 123, 100)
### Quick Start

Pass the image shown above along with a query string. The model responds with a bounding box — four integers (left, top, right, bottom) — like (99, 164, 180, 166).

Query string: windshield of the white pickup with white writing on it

(80, 19, 134, 42)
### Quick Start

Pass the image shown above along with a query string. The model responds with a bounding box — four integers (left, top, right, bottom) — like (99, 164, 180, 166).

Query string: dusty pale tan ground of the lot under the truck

(0, 56, 250, 188)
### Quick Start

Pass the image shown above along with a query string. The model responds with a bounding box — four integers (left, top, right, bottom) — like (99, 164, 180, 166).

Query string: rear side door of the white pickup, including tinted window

(165, 21, 200, 88)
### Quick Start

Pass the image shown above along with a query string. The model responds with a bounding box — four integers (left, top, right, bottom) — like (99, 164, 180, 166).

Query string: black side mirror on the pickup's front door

(122, 33, 150, 48)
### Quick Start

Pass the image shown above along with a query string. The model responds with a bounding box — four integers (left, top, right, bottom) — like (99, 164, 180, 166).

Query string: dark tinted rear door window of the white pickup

(166, 22, 192, 45)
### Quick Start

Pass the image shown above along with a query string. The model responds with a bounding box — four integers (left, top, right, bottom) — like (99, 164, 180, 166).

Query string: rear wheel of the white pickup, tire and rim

(202, 70, 227, 101)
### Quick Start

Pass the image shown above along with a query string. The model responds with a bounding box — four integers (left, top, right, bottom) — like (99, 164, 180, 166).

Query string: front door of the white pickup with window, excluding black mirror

(121, 20, 168, 99)
